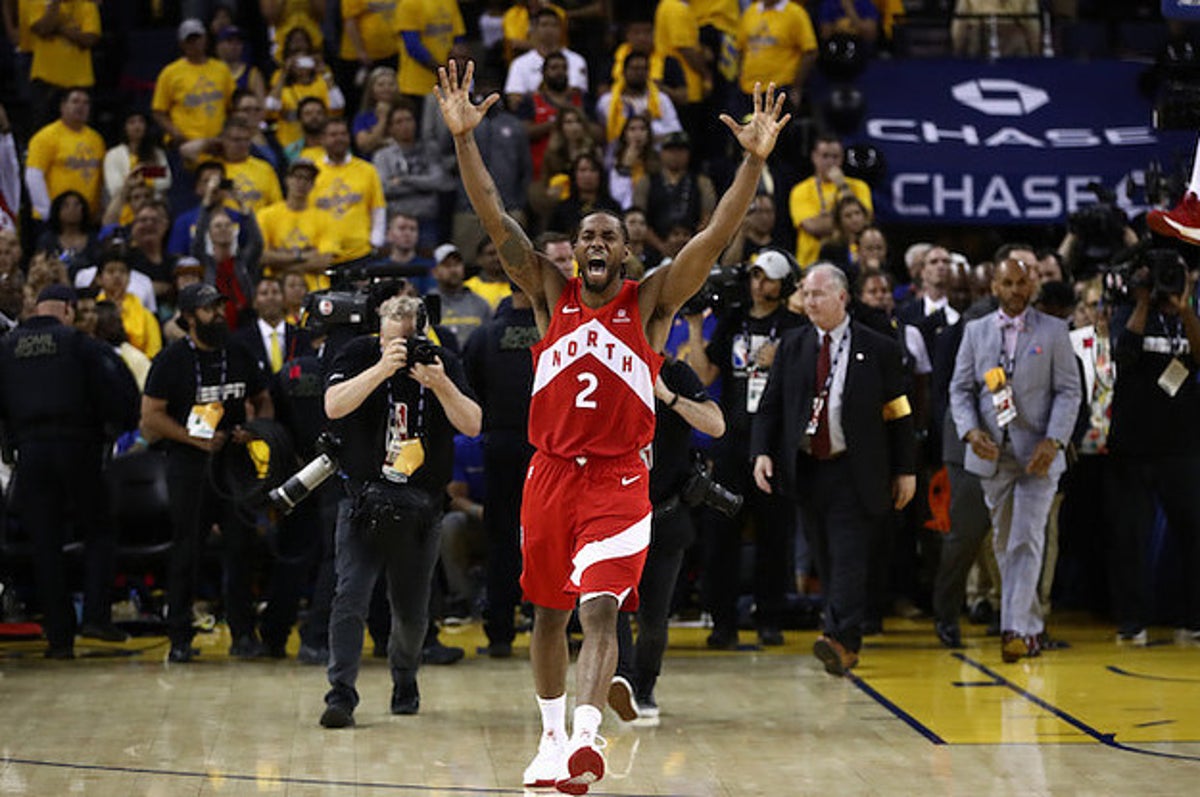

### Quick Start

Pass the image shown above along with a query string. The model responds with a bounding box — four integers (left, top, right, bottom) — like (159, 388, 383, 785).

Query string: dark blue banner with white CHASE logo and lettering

(848, 59, 1196, 224)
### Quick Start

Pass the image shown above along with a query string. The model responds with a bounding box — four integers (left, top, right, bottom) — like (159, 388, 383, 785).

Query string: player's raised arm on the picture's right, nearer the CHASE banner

(641, 83, 792, 343)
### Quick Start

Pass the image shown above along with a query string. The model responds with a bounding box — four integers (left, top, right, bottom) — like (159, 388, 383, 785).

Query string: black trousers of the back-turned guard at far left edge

(17, 441, 116, 648)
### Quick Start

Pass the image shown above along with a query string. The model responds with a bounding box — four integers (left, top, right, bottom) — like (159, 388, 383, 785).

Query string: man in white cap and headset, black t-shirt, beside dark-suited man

(688, 250, 800, 651)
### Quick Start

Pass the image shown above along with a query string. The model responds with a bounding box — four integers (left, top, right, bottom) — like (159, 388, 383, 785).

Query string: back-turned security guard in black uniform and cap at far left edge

(0, 284, 138, 659)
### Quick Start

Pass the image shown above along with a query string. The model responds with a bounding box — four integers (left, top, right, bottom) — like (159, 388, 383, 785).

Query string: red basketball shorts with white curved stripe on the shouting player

(521, 451, 653, 611)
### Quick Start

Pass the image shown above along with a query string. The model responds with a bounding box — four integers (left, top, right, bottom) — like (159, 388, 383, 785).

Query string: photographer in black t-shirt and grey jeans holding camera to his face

(320, 296, 482, 727)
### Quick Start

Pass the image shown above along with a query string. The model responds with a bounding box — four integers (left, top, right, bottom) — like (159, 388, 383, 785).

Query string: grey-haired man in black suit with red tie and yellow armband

(750, 264, 917, 676)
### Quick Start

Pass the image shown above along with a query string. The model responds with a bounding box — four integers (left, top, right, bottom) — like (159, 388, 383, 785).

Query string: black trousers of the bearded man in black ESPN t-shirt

(167, 443, 254, 646)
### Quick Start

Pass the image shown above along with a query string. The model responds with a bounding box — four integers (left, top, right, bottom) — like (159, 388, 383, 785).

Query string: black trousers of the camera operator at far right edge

(1105, 454, 1200, 631)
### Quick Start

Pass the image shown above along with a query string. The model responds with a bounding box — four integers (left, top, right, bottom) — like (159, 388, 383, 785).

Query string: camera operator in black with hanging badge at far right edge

(1105, 250, 1200, 645)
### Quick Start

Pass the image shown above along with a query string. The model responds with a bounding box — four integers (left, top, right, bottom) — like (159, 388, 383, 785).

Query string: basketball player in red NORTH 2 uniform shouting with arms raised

(436, 61, 788, 795)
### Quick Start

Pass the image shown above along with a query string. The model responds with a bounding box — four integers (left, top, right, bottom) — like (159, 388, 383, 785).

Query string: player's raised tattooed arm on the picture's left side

(433, 61, 546, 304)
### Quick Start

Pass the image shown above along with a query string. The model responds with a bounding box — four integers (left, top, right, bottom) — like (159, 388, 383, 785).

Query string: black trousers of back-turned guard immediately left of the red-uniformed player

(484, 432, 533, 645)
